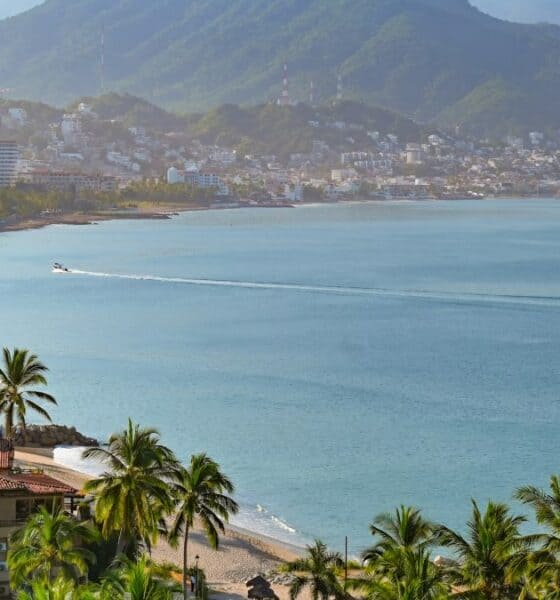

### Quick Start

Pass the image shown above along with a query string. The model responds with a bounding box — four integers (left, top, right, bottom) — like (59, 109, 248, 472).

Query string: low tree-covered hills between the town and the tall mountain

(0, 93, 425, 159)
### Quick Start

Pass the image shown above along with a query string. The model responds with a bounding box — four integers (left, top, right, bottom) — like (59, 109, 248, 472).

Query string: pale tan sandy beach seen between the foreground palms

(15, 449, 303, 600)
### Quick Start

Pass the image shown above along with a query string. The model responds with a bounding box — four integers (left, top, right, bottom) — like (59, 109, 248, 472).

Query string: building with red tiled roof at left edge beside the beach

(0, 438, 78, 600)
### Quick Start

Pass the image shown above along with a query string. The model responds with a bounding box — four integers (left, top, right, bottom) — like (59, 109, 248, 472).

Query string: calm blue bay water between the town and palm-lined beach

(0, 200, 560, 553)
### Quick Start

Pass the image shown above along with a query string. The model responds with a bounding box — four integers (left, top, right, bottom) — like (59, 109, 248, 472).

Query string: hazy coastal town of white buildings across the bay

(0, 96, 560, 225)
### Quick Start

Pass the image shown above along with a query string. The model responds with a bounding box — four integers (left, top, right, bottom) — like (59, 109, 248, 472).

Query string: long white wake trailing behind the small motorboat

(60, 269, 560, 307)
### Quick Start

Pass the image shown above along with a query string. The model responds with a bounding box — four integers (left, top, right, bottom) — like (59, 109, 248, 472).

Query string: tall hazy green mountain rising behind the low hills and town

(0, 0, 560, 134)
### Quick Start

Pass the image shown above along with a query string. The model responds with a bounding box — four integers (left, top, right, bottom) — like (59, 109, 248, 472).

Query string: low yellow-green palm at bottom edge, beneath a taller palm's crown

(348, 548, 451, 600)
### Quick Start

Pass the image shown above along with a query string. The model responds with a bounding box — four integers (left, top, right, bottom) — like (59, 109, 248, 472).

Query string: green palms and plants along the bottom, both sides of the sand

(7, 410, 560, 600)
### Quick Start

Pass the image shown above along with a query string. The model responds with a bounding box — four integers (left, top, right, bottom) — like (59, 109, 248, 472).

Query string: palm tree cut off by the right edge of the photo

(515, 475, 560, 599)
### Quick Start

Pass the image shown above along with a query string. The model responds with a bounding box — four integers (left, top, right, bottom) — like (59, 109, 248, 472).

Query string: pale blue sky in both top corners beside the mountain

(0, 0, 560, 24)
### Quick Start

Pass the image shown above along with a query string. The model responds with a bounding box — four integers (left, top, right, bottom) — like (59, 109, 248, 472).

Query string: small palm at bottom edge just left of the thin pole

(283, 540, 347, 600)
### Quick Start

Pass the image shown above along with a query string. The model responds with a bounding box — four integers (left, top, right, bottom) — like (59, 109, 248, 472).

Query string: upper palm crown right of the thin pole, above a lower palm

(362, 506, 434, 564)
